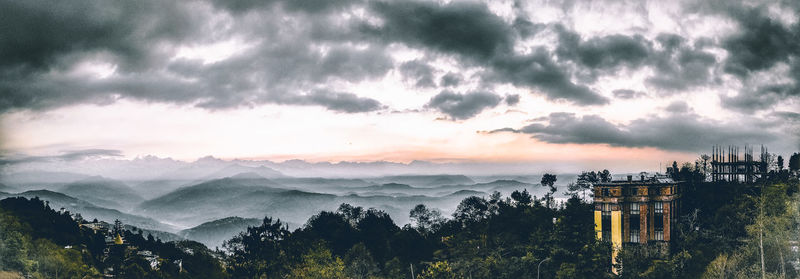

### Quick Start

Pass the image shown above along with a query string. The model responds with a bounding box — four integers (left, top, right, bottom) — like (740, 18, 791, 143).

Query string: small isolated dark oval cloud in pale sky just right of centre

(426, 91, 502, 120)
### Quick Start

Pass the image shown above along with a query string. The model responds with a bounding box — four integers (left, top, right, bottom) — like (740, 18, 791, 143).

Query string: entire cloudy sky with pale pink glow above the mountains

(0, 0, 800, 174)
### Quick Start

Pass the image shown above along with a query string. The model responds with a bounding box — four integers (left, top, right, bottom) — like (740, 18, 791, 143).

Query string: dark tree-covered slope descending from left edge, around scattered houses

(0, 198, 227, 278)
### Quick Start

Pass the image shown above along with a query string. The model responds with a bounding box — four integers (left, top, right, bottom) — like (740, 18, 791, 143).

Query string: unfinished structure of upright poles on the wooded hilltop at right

(711, 145, 769, 183)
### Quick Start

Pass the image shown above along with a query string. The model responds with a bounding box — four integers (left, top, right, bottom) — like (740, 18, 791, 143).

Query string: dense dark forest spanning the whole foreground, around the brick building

(0, 156, 800, 279)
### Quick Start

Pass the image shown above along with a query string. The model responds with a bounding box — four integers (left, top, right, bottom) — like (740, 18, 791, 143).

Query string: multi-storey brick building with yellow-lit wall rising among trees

(593, 175, 681, 270)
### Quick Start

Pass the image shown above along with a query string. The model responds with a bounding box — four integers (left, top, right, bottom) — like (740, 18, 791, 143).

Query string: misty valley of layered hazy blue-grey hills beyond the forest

(0, 158, 570, 249)
